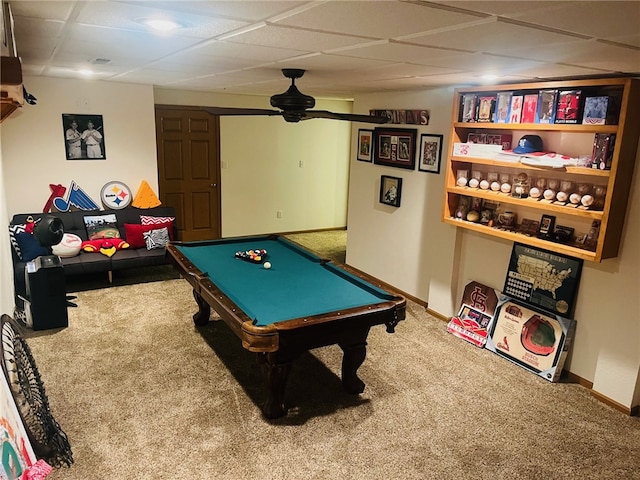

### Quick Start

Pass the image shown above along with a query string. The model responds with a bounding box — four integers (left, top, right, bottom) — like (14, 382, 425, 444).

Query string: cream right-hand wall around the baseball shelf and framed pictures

(347, 85, 640, 408)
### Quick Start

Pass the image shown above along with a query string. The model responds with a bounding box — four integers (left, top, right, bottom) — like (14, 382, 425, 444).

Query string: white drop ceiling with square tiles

(9, 0, 640, 99)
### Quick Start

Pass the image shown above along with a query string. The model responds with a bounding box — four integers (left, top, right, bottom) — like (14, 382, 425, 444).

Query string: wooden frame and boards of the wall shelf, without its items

(442, 78, 640, 262)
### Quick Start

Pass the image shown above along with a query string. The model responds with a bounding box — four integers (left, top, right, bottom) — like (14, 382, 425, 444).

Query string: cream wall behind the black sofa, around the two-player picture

(2, 77, 158, 216)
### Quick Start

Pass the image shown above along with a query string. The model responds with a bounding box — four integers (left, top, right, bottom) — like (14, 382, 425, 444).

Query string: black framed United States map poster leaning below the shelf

(502, 242, 582, 317)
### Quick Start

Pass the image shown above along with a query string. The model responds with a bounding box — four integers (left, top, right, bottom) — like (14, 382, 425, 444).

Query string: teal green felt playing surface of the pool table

(177, 237, 392, 326)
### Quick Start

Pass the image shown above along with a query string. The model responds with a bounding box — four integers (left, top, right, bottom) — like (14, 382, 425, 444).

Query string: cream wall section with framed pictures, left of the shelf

(347, 88, 456, 315)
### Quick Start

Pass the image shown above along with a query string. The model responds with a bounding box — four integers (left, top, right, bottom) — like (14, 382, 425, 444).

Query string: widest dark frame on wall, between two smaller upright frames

(373, 128, 418, 170)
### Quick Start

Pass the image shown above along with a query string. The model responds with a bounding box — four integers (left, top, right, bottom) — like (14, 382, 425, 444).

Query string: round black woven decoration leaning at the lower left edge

(0, 315, 73, 467)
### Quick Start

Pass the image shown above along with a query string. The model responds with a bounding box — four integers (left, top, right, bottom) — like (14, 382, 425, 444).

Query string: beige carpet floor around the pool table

(21, 233, 640, 480)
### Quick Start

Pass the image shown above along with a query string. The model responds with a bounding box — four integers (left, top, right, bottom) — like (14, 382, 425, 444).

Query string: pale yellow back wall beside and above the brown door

(155, 88, 351, 237)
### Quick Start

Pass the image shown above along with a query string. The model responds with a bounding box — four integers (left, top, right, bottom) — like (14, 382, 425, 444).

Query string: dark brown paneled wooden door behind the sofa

(156, 105, 221, 241)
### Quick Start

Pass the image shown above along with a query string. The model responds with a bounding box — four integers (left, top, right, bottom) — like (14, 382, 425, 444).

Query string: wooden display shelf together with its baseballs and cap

(442, 78, 640, 262)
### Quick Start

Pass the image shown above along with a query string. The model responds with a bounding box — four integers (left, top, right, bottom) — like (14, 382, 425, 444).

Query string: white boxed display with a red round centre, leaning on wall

(485, 296, 576, 382)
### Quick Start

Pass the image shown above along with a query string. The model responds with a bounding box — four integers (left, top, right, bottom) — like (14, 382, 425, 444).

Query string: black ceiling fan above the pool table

(202, 68, 389, 124)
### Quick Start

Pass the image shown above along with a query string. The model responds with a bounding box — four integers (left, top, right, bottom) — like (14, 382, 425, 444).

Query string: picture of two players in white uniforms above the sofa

(62, 113, 107, 160)
